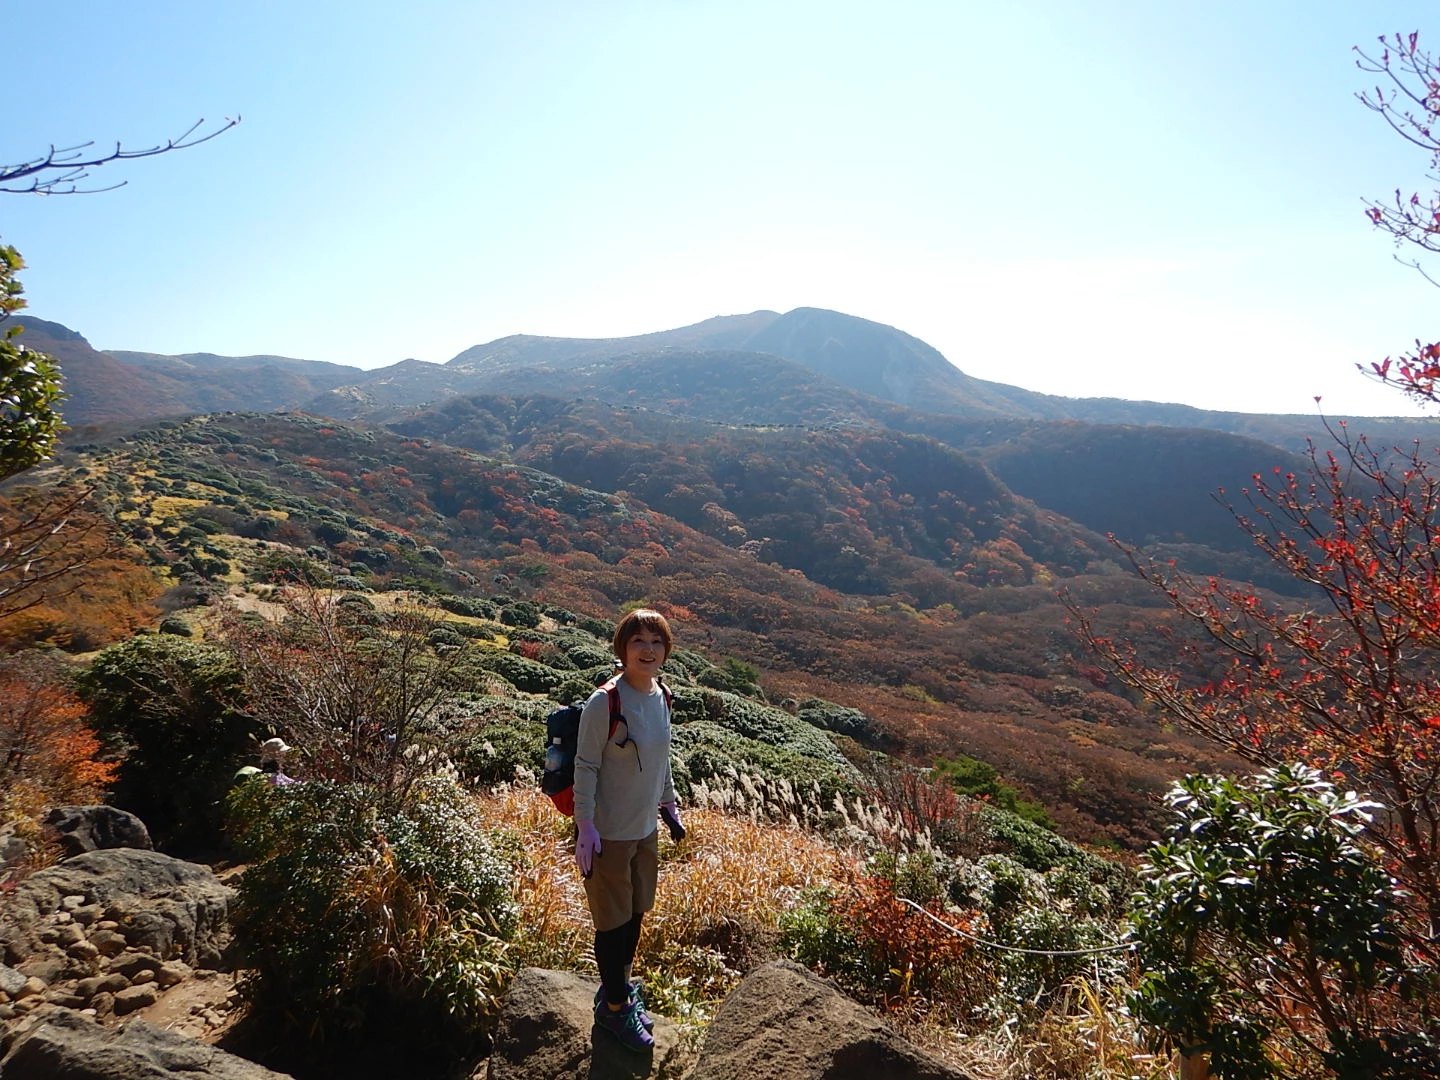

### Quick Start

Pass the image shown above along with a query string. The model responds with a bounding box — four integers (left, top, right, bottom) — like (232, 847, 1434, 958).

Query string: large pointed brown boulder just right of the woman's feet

(688, 960, 966, 1080)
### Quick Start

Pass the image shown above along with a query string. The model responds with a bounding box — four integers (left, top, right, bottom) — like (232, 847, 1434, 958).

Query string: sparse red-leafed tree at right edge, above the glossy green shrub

(1071, 428, 1440, 959)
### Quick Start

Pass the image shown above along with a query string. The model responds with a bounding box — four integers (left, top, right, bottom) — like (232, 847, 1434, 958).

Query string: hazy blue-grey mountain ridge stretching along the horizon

(20, 308, 1431, 449)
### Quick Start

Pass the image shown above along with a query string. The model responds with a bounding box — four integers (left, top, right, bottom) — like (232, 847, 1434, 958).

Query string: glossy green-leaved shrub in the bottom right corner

(1130, 765, 1440, 1080)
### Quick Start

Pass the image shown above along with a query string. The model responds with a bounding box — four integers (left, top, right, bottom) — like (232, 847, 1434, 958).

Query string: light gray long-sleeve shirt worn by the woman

(575, 678, 675, 840)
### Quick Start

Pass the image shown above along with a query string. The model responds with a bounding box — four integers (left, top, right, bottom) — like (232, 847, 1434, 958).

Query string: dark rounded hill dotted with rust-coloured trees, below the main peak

(393, 397, 1110, 608)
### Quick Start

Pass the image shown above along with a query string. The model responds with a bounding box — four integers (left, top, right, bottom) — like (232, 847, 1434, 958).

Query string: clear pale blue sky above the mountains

(0, 0, 1440, 413)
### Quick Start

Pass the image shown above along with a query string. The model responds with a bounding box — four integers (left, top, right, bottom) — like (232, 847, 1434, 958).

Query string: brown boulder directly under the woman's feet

(486, 968, 685, 1080)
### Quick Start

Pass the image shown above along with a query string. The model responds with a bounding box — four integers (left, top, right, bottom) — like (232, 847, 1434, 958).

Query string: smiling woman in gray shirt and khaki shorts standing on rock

(575, 608, 684, 1051)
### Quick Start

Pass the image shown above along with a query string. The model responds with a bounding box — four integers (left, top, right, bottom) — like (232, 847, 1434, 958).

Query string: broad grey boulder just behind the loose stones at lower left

(0, 848, 235, 968)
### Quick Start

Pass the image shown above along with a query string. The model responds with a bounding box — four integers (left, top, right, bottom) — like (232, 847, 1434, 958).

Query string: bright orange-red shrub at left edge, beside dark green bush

(0, 652, 115, 821)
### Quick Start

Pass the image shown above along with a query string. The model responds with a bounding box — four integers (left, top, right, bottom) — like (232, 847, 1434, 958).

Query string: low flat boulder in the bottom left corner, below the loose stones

(0, 1009, 285, 1080)
